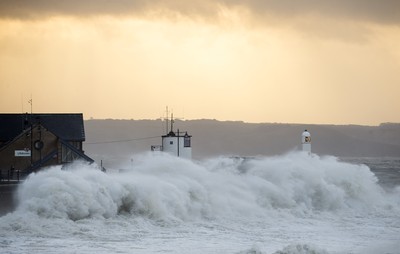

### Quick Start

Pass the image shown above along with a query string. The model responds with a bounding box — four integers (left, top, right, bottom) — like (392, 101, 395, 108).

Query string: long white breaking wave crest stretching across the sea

(13, 153, 400, 221)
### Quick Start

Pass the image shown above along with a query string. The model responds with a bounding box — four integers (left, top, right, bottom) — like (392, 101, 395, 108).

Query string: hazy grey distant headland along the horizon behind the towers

(84, 119, 400, 165)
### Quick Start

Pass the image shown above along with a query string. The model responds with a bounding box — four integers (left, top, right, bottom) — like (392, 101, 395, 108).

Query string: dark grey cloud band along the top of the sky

(0, 0, 400, 25)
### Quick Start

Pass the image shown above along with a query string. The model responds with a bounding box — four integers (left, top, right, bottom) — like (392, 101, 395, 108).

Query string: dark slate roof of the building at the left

(0, 114, 85, 142)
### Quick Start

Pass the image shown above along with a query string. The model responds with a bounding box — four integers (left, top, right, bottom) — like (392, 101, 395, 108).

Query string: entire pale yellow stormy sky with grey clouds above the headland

(0, 0, 400, 124)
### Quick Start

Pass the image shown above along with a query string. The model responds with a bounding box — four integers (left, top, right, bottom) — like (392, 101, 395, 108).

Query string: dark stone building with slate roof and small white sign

(0, 113, 93, 180)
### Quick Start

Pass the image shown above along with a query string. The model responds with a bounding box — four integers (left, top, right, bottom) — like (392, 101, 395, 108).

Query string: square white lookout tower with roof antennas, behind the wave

(151, 113, 192, 160)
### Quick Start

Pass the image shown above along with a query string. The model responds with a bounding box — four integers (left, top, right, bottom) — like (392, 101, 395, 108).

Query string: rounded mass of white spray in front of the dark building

(18, 162, 124, 220)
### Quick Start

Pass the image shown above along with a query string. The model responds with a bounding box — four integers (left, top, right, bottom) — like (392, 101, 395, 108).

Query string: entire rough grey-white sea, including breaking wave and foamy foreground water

(0, 152, 400, 254)
